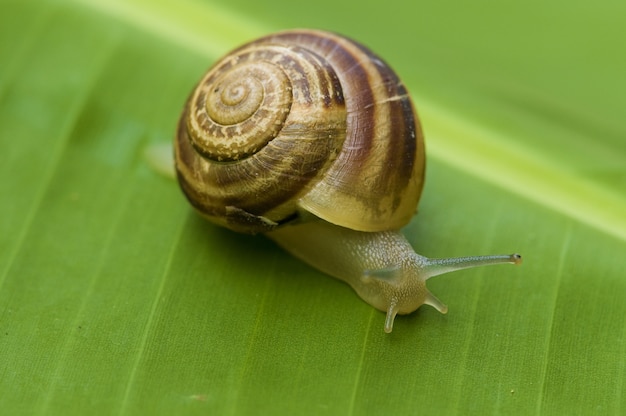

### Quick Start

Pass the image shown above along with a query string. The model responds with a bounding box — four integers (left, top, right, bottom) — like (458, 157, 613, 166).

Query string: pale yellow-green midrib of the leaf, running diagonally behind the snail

(70, 0, 626, 241)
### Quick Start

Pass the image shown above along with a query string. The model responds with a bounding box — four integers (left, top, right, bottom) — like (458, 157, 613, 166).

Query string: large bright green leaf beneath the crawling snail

(0, 0, 626, 415)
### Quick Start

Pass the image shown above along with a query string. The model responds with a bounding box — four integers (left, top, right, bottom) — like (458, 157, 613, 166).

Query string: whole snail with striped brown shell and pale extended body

(174, 30, 521, 332)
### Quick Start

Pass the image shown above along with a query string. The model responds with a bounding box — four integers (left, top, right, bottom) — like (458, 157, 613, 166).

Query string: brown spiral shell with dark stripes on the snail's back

(175, 30, 424, 233)
